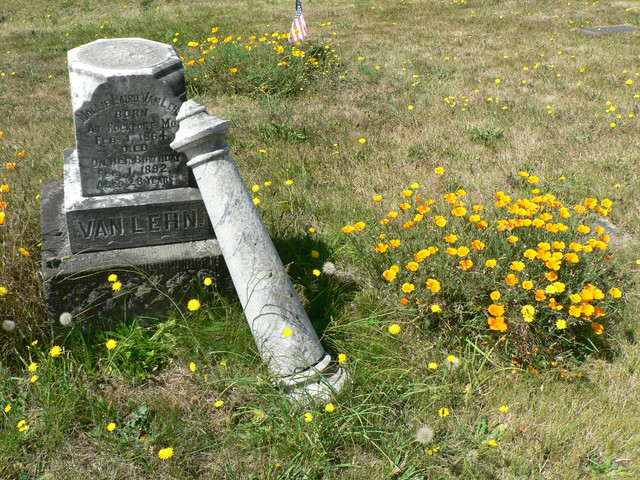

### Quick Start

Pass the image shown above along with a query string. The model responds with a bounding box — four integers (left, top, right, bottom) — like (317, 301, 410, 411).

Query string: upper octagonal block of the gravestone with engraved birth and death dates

(68, 38, 188, 197)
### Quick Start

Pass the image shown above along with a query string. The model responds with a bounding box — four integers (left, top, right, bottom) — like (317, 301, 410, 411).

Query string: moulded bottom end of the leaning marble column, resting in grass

(274, 355, 347, 403)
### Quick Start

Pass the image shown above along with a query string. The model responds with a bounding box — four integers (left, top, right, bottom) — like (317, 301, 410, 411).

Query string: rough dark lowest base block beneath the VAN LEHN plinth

(42, 180, 234, 329)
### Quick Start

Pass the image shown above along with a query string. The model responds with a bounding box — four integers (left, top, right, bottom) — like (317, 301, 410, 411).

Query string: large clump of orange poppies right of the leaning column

(343, 172, 622, 342)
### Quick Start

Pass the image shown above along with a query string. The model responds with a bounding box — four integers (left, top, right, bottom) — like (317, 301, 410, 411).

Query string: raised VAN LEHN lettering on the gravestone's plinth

(73, 208, 206, 241)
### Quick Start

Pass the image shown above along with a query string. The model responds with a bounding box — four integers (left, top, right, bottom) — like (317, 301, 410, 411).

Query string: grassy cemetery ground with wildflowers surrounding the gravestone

(0, 0, 640, 479)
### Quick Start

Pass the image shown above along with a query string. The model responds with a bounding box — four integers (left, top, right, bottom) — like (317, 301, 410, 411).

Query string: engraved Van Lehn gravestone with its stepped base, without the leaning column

(42, 38, 231, 326)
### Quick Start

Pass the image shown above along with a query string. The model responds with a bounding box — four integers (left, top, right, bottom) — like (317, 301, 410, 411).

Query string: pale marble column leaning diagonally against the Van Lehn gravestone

(171, 100, 346, 399)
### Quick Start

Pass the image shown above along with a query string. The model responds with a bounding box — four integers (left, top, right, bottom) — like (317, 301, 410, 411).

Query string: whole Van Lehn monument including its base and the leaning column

(42, 39, 346, 399)
